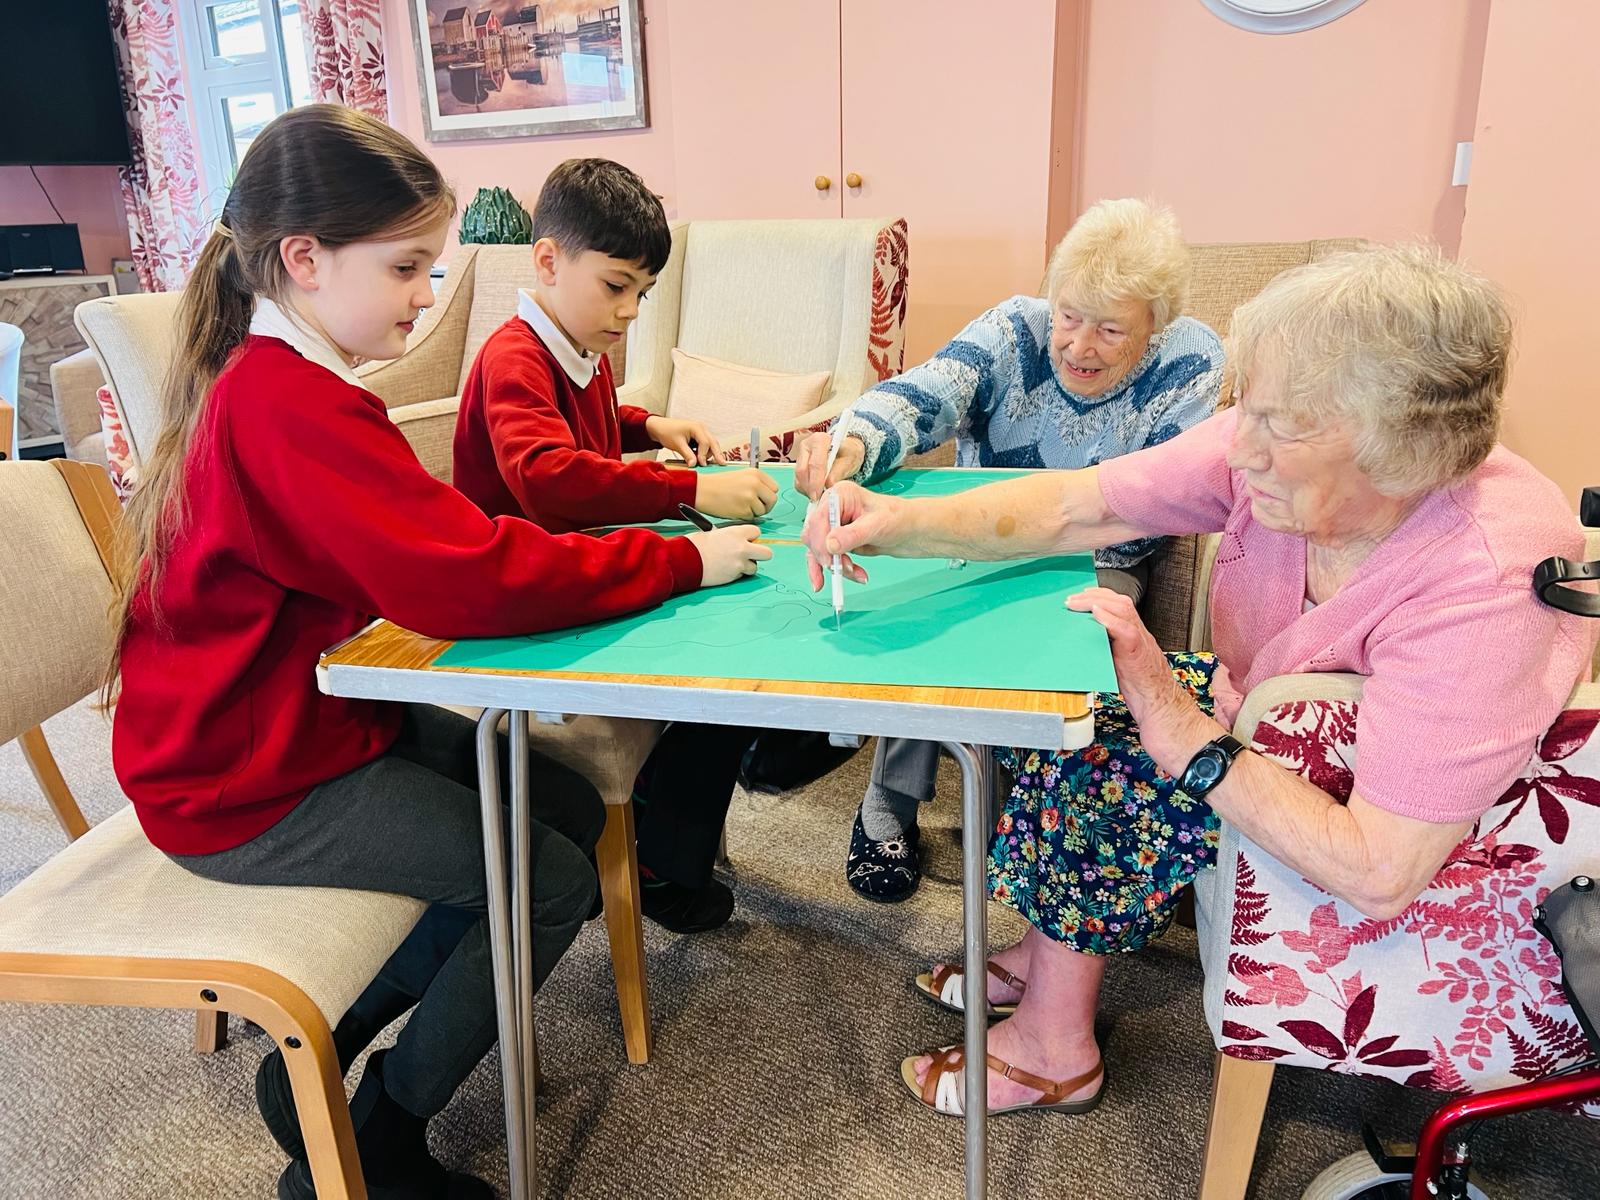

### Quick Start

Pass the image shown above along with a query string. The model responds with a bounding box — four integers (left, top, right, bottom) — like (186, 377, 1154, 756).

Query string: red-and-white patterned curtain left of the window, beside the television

(107, 0, 210, 291)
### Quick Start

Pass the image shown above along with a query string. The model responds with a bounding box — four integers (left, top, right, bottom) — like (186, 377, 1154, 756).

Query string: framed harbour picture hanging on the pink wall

(411, 0, 650, 142)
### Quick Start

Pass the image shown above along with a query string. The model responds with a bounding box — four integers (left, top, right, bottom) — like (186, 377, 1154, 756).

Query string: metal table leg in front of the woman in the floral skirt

(944, 742, 994, 1200)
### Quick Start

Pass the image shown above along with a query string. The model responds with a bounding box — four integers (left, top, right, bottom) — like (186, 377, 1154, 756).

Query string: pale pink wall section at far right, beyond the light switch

(1461, 0, 1600, 506)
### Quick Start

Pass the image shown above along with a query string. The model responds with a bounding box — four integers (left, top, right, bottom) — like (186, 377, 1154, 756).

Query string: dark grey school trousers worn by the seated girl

(171, 704, 605, 1117)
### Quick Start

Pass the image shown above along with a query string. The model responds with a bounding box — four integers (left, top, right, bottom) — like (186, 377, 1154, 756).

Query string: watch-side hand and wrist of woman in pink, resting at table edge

(1067, 587, 1216, 774)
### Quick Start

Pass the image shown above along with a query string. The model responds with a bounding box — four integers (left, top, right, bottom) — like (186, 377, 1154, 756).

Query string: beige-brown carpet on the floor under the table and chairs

(0, 706, 1600, 1200)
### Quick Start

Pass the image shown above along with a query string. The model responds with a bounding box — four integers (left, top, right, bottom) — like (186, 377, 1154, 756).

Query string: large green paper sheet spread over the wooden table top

(437, 469, 1117, 691)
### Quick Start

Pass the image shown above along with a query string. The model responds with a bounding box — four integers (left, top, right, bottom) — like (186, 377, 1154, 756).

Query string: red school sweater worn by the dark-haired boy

(451, 317, 696, 533)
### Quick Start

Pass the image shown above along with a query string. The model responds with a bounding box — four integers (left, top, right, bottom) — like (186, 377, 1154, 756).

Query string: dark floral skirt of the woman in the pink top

(989, 653, 1218, 954)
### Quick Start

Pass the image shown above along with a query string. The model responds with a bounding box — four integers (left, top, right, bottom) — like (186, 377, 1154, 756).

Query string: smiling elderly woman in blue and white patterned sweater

(795, 200, 1222, 901)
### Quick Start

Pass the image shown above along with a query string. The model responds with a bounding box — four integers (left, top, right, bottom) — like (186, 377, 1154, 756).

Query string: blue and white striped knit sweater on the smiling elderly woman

(850, 296, 1222, 566)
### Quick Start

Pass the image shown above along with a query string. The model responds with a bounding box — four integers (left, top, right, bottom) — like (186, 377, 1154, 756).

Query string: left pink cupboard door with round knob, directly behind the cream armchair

(662, 0, 845, 221)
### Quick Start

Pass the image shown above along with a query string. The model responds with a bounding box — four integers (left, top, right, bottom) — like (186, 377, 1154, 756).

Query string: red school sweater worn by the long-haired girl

(112, 336, 701, 854)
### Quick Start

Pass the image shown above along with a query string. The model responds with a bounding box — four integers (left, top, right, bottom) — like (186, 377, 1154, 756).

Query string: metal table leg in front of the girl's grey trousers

(478, 709, 533, 1200)
